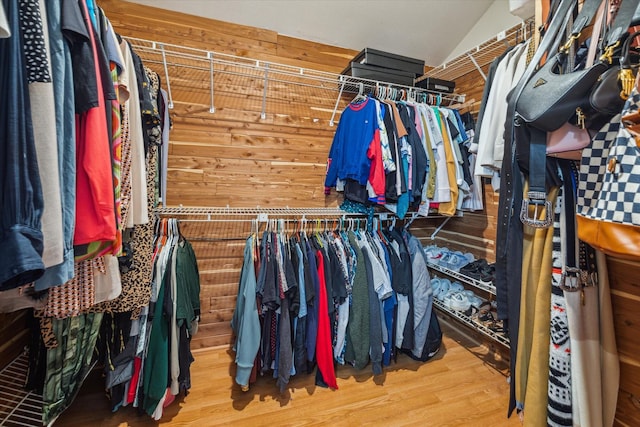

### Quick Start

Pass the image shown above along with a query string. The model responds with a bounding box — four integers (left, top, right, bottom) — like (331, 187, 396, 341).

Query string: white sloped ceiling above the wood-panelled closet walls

(127, 0, 520, 66)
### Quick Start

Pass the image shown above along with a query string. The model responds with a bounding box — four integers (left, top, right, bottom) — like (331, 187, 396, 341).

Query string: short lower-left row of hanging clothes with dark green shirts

(103, 218, 200, 420)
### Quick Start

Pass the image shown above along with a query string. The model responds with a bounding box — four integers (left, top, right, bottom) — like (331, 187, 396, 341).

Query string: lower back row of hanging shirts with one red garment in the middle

(231, 221, 441, 391)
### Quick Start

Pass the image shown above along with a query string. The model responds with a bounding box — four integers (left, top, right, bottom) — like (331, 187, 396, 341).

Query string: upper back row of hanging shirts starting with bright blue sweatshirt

(325, 89, 482, 219)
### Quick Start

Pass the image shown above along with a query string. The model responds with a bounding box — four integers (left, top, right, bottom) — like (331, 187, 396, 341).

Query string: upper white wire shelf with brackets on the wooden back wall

(127, 38, 464, 125)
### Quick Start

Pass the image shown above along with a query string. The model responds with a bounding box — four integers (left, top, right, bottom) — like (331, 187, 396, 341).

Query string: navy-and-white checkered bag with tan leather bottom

(577, 88, 640, 259)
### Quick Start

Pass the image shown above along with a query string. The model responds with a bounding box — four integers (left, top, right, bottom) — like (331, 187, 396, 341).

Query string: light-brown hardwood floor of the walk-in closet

(55, 321, 520, 427)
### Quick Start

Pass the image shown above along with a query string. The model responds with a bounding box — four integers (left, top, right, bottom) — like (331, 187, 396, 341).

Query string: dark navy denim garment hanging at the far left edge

(0, 0, 45, 289)
